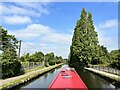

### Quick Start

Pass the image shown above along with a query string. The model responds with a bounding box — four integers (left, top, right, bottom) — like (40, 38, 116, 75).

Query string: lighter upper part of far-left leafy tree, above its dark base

(0, 26, 18, 60)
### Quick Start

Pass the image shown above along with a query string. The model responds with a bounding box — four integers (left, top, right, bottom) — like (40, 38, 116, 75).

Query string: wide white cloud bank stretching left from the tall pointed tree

(9, 24, 72, 44)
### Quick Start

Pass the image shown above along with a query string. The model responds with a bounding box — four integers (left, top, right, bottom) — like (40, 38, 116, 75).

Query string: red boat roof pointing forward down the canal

(49, 67, 87, 90)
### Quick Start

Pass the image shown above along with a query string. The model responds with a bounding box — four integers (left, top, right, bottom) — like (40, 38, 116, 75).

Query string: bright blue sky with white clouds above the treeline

(0, 2, 118, 58)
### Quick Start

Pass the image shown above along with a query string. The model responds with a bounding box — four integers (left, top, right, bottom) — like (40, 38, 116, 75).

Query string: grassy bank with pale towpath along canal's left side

(0, 63, 63, 90)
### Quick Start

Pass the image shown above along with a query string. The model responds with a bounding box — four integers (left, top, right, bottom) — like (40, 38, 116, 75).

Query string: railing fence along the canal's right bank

(90, 65, 120, 76)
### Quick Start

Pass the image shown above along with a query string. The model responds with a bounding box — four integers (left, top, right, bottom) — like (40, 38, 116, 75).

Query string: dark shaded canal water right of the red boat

(76, 68, 118, 90)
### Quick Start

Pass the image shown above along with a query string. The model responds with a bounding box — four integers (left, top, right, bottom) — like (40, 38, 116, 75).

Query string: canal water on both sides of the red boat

(12, 65, 120, 90)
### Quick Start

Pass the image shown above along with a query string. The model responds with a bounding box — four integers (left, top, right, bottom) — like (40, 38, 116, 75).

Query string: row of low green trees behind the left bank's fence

(20, 52, 63, 67)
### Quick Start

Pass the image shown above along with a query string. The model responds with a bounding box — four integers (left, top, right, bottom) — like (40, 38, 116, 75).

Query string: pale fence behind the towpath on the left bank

(21, 62, 44, 70)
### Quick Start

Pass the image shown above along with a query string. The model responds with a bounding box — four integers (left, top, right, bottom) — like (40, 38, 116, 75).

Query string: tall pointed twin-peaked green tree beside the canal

(69, 8, 99, 65)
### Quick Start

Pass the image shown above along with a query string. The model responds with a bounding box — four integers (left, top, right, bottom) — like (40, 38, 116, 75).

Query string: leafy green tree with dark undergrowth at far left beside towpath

(0, 27, 24, 78)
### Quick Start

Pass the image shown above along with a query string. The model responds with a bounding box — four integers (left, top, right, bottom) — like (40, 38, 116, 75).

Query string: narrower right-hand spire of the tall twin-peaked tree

(86, 12, 99, 63)
